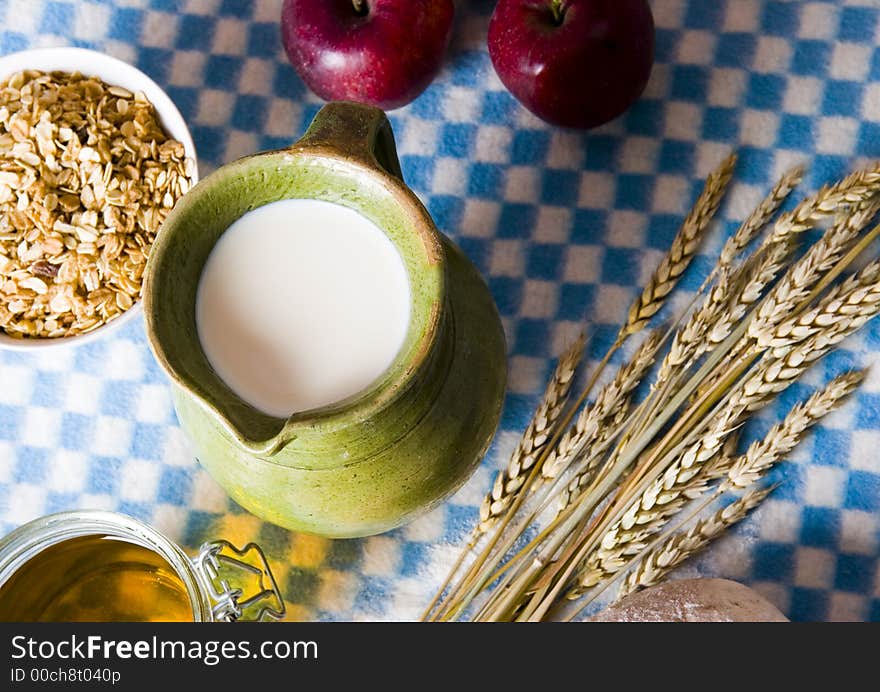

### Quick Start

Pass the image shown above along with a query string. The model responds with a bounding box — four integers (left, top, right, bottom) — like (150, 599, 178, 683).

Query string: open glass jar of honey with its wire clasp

(0, 510, 284, 622)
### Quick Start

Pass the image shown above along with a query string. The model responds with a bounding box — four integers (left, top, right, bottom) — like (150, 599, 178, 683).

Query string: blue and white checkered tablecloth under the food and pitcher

(0, 0, 880, 620)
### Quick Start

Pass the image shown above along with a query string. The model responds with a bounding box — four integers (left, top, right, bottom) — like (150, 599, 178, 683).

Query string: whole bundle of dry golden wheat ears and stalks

(428, 157, 880, 621)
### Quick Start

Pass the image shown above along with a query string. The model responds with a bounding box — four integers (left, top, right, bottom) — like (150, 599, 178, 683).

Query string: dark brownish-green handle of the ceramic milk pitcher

(293, 101, 403, 182)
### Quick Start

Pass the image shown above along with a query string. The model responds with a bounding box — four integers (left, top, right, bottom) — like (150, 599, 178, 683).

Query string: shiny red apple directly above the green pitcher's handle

(281, 0, 455, 110)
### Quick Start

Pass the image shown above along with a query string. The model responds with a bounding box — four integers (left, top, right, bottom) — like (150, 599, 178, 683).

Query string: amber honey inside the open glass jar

(0, 534, 193, 622)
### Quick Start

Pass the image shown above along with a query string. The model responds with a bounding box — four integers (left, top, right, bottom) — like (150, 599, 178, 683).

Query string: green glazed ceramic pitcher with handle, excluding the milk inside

(144, 102, 506, 537)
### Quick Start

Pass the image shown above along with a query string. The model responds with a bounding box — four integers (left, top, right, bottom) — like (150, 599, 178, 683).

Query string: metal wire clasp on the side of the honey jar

(193, 540, 285, 622)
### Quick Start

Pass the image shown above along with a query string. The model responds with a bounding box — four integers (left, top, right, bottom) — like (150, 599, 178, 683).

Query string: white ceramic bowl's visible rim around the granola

(0, 48, 198, 351)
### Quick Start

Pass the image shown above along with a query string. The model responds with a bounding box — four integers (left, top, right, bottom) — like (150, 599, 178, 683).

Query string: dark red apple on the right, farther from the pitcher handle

(489, 0, 654, 129)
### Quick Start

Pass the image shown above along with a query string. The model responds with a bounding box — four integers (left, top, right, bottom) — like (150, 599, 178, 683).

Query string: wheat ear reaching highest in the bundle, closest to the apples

(618, 154, 736, 340)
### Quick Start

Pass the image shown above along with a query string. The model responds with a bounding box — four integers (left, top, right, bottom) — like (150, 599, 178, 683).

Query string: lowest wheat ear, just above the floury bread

(617, 487, 775, 599)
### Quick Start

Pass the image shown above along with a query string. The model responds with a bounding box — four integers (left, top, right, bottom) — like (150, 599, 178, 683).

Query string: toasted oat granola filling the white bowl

(0, 71, 194, 338)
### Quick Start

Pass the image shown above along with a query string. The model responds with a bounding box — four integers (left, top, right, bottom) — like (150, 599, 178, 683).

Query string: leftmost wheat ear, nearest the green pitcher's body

(474, 335, 584, 538)
